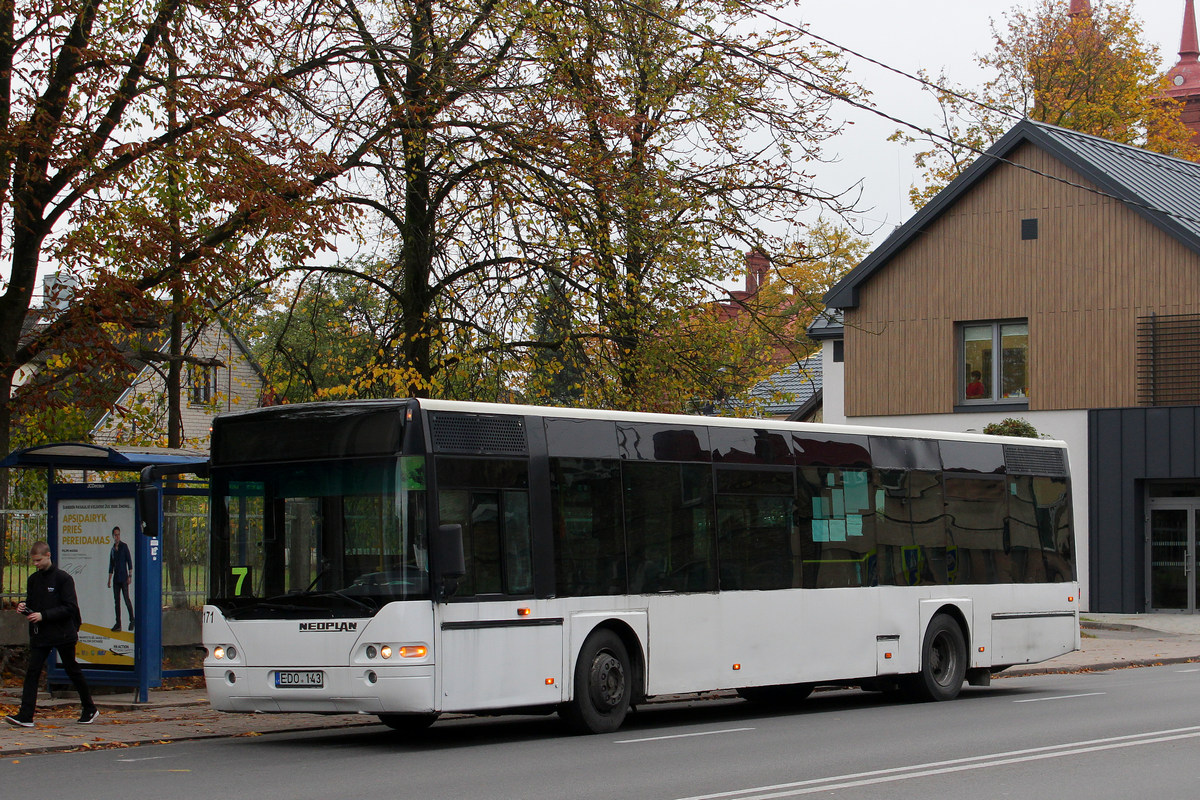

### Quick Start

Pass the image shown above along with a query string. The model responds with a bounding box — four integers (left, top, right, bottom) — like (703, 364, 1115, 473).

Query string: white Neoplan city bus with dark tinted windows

(196, 399, 1079, 733)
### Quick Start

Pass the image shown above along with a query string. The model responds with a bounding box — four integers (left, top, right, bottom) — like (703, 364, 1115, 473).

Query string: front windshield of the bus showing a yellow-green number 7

(209, 456, 430, 619)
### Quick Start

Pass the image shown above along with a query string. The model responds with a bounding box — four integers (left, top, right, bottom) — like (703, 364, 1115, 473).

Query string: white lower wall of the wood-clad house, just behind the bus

(821, 342, 1090, 610)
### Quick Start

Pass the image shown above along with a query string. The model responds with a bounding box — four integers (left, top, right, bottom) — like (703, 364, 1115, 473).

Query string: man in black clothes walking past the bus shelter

(4, 542, 100, 728)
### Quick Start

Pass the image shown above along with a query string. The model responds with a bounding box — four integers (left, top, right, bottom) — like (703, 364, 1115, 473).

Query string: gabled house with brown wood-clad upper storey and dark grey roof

(810, 120, 1200, 613)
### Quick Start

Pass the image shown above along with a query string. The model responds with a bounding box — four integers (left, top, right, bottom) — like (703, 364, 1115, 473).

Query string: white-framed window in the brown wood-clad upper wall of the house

(958, 319, 1030, 405)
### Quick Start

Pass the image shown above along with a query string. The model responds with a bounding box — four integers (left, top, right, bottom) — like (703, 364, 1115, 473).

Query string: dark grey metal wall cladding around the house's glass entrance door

(1087, 407, 1200, 614)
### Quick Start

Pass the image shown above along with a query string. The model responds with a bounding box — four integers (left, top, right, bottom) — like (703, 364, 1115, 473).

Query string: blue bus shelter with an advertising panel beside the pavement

(0, 443, 208, 703)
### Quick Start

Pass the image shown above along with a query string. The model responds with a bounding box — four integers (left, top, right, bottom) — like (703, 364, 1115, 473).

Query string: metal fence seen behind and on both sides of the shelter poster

(0, 497, 209, 609)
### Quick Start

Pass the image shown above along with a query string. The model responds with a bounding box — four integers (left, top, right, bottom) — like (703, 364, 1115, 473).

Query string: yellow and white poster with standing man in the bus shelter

(58, 498, 136, 667)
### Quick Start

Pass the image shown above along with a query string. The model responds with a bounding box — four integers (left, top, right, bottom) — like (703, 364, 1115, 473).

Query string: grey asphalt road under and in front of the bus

(9, 664, 1200, 800)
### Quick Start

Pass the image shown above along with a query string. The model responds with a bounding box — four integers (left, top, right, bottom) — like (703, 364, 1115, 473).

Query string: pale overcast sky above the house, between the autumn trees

(794, 0, 1184, 242)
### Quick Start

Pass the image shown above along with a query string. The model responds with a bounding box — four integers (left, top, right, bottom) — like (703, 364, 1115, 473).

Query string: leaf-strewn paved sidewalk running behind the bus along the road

(0, 614, 1200, 759)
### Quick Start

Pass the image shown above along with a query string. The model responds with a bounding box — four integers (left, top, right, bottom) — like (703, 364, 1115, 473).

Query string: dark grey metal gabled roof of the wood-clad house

(824, 120, 1200, 308)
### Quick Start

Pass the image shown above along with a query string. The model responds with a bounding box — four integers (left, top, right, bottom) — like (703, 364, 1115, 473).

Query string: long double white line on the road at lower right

(679, 726, 1200, 800)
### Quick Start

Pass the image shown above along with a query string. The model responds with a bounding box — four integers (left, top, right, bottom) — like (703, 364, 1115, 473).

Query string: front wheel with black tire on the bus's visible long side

(559, 628, 634, 733)
